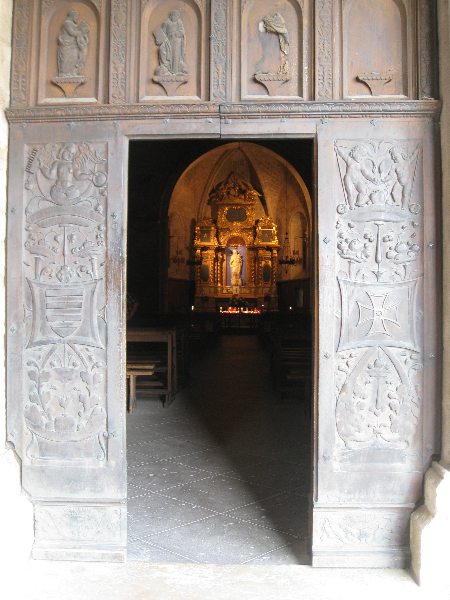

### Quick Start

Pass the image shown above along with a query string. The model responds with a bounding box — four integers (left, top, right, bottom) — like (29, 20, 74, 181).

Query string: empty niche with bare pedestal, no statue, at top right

(343, 0, 410, 98)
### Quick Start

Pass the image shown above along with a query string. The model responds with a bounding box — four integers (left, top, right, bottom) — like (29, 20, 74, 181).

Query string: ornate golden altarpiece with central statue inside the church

(193, 171, 280, 312)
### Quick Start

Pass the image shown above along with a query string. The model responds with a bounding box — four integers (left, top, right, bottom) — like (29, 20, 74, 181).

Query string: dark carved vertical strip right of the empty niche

(419, 0, 437, 99)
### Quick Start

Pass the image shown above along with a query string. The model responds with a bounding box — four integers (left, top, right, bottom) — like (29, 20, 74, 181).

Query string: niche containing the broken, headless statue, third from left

(240, 0, 309, 99)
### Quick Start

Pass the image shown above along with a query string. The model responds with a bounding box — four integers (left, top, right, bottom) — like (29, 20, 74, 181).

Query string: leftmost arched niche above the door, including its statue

(38, 0, 105, 104)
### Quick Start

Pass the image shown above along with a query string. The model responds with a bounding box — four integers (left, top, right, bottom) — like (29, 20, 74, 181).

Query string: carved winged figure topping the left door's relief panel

(39, 143, 106, 205)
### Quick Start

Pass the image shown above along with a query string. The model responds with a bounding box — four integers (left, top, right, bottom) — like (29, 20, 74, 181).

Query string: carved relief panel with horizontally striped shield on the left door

(24, 143, 107, 462)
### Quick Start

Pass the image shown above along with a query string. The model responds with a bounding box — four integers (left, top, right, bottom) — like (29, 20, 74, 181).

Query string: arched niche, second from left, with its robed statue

(139, 0, 207, 102)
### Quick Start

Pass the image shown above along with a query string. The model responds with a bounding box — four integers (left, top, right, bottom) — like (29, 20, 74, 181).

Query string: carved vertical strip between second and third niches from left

(211, 0, 227, 100)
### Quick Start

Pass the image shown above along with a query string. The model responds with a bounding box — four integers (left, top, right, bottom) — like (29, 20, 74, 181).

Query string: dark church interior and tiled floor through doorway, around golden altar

(127, 140, 313, 564)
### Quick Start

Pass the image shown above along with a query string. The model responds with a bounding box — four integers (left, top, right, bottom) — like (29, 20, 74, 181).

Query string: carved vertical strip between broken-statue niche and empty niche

(316, 0, 333, 100)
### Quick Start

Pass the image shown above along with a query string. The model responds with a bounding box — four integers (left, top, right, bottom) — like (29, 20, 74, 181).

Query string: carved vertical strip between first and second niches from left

(109, 0, 128, 104)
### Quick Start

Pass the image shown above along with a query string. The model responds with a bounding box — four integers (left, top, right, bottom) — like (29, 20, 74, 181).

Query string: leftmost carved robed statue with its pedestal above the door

(52, 10, 90, 98)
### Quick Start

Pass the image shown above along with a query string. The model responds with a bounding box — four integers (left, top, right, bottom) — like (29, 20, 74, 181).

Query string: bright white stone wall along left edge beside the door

(0, 0, 33, 574)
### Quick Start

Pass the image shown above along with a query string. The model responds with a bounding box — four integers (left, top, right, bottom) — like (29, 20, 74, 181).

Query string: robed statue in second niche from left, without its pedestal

(153, 10, 188, 76)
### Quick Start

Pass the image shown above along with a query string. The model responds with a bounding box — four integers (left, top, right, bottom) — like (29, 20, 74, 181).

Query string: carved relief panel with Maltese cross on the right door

(335, 140, 423, 451)
